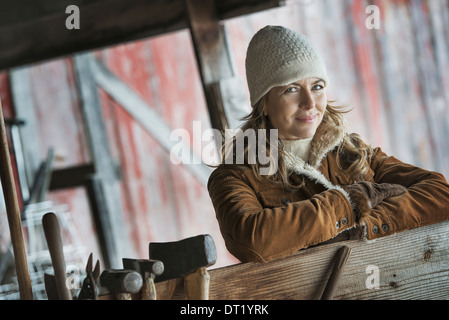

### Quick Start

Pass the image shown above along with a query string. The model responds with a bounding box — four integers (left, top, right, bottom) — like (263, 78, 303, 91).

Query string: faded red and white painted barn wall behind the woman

(0, 0, 449, 298)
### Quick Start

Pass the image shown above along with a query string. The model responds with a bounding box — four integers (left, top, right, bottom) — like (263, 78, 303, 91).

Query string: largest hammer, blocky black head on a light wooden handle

(150, 234, 217, 300)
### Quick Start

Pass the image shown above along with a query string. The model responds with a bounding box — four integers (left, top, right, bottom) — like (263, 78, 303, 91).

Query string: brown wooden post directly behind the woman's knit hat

(186, 0, 246, 131)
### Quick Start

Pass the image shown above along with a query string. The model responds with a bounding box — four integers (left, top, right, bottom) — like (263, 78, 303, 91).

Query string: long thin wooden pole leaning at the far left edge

(0, 100, 33, 300)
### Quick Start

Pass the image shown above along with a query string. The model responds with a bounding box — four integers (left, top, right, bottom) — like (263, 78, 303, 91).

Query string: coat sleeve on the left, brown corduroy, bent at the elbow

(208, 168, 355, 262)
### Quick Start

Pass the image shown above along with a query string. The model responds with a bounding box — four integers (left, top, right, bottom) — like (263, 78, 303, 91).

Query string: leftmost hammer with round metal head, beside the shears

(100, 269, 143, 300)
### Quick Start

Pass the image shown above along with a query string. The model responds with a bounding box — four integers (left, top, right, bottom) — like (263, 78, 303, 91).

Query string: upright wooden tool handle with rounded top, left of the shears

(42, 213, 72, 300)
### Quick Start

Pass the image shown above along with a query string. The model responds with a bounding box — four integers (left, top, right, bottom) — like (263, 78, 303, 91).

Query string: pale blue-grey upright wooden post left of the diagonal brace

(75, 53, 132, 268)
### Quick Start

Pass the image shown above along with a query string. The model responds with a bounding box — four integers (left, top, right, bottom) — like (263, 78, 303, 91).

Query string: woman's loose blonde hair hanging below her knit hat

(222, 94, 373, 191)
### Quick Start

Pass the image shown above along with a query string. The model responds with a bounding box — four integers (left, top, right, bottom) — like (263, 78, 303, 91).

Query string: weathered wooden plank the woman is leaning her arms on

(151, 222, 449, 300)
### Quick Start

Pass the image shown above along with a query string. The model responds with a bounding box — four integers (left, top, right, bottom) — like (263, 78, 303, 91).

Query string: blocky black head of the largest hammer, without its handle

(150, 234, 217, 282)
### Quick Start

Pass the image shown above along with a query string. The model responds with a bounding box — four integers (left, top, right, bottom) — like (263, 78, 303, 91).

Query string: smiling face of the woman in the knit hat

(265, 78, 327, 140)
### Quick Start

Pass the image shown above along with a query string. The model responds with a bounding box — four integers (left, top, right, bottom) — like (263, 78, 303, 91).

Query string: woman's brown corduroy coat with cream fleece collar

(208, 117, 449, 262)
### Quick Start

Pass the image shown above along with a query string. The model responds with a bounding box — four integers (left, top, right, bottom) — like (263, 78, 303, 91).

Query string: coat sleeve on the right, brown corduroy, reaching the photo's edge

(361, 148, 449, 240)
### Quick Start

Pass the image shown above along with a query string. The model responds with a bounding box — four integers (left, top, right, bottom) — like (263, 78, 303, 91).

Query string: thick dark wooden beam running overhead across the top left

(0, 0, 283, 70)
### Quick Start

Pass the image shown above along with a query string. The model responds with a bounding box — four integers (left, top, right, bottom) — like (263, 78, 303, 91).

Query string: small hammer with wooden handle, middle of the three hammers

(122, 258, 164, 300)
